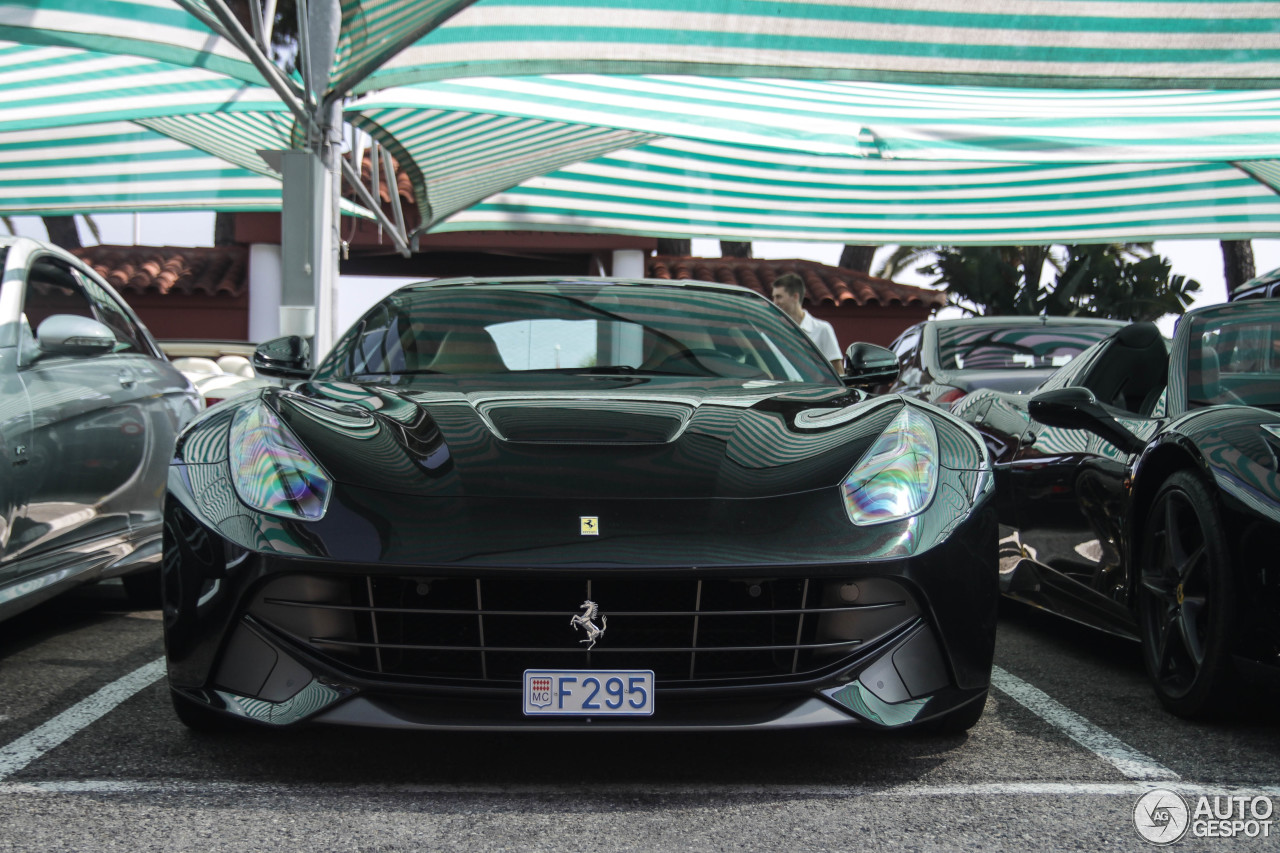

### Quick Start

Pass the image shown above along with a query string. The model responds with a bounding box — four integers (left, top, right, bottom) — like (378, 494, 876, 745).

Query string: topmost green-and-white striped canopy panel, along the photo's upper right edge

(357, 0, 1280, 91)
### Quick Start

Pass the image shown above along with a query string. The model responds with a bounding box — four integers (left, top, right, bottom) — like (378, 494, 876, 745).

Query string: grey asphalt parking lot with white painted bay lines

(0, 585, 1280, 852)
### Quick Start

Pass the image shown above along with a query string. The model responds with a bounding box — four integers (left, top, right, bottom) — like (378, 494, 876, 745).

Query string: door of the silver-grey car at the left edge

(6, 251, 172, 576)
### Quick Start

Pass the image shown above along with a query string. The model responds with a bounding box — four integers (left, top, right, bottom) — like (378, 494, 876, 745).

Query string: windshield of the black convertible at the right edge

(1187, 300, 1280, 410)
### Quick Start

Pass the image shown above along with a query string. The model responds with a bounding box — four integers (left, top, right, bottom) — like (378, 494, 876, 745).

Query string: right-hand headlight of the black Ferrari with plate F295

(841, 405, 938, 526)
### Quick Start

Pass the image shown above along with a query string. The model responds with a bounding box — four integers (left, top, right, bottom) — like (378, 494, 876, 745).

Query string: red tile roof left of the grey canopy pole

(73, 245, 248, 296)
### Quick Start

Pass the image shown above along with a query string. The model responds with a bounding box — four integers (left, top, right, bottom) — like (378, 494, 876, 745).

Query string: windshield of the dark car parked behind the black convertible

(938, 324, 1119, 370)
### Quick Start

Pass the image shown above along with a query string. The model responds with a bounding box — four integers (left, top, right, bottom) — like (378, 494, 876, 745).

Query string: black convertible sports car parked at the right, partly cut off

(955, 300, 1280, 716)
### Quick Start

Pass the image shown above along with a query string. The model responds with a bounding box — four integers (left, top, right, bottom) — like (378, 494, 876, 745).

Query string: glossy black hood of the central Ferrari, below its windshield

(261, 377, 902, 498)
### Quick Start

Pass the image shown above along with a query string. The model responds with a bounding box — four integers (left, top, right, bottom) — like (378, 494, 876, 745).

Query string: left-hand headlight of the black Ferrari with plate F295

(230, 401, 332, 521)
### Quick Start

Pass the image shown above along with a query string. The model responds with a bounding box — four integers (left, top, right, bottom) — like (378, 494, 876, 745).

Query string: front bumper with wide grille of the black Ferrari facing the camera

(164, 489, 998, 731)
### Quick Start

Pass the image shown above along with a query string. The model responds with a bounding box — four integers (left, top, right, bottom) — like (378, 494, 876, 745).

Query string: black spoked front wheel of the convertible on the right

(1138, 471, 1235, 717)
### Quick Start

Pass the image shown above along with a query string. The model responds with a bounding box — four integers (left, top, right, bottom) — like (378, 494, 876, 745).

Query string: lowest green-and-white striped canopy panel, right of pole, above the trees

(433, 145, 1280, 245)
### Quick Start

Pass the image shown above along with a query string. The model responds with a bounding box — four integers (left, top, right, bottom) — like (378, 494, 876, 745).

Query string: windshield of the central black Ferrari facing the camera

(316, 282, 836, 384)
